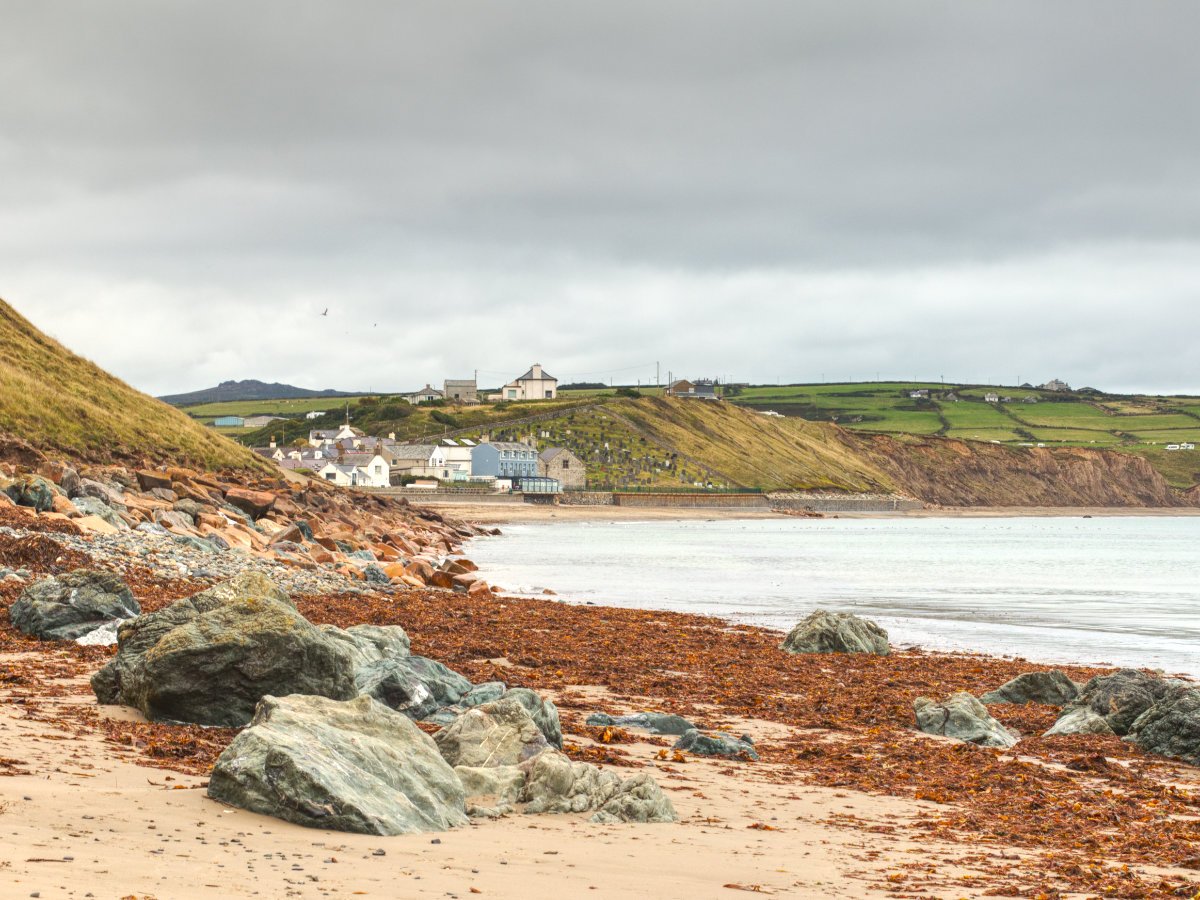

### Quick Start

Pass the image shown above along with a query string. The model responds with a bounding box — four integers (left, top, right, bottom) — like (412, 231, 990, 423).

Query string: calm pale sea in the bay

(468, 517, 1200, 676)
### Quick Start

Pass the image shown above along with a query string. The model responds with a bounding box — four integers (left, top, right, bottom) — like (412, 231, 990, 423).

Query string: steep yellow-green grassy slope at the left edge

(0, 300, 263, 469)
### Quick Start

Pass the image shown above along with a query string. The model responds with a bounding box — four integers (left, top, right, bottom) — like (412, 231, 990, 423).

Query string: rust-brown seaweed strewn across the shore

(0, 494, 1200, 898)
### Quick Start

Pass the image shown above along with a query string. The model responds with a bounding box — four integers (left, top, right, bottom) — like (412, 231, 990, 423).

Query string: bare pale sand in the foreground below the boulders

(0, 679, 982, 900)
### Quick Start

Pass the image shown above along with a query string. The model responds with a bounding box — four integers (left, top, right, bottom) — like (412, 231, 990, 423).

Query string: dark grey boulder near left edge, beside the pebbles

(8, 569, 142, 641)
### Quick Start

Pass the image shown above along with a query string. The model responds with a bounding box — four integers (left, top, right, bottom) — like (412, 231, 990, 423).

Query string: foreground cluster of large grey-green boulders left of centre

(84, 572, 676, 834)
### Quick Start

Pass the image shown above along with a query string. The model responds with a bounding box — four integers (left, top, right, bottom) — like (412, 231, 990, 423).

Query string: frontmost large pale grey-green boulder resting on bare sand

(209, 696, 467, 835)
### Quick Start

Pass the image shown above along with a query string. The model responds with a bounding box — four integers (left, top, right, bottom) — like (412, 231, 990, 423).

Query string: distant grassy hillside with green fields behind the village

(220, 382, 1200, 496)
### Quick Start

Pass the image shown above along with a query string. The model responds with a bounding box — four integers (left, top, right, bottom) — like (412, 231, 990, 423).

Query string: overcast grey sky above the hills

(0, 0, 1200, 394)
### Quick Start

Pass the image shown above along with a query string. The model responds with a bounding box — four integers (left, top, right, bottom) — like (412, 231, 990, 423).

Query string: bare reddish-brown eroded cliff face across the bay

(844, 432, 1200, 508)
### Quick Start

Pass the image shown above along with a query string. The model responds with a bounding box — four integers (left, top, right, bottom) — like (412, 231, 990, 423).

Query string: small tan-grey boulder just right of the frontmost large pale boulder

(433, 697, 550, 767)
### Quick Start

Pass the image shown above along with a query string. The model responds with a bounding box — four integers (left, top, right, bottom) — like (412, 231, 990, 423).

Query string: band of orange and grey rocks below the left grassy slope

(0, 461, 491, 595)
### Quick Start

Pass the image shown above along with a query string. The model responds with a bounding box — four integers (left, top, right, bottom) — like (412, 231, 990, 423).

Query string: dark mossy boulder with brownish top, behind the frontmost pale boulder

(92, 572, 358, 726)
